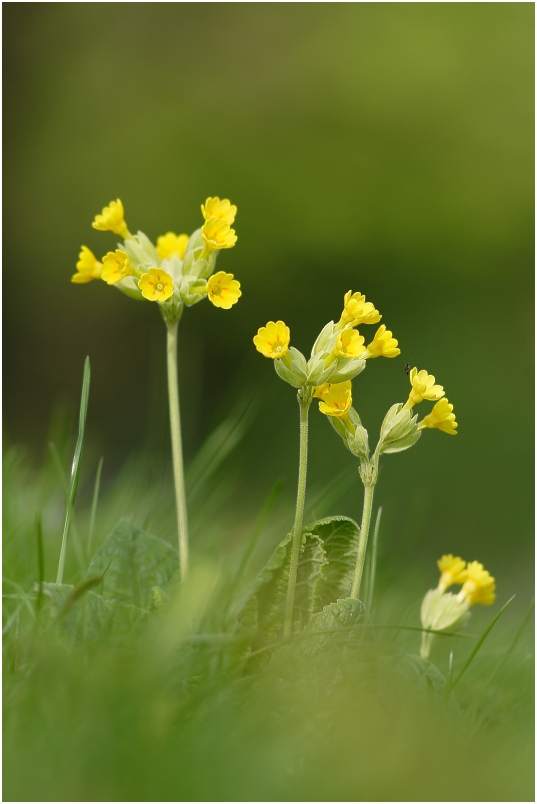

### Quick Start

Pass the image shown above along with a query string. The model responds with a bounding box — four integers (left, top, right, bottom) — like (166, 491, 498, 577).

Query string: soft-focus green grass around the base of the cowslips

(3, 398, 533, 801)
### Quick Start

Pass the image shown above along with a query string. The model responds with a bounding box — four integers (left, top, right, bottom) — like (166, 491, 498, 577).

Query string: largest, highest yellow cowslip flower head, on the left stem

(71, 197, 241, 321)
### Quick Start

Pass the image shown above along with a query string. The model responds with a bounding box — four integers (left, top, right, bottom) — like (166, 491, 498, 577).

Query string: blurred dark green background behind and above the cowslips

(4, 3, 534, 584)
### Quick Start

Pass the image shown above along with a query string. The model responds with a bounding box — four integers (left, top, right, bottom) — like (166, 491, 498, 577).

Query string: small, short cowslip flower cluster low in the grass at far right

(420, 553, 496, 659)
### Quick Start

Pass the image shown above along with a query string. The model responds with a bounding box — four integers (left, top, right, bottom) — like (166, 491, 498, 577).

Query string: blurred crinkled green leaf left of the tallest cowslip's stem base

(88, 519, 179, 609)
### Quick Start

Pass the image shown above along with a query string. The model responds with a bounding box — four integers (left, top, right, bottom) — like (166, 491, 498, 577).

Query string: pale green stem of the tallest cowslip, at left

(166, 321, 188, 581)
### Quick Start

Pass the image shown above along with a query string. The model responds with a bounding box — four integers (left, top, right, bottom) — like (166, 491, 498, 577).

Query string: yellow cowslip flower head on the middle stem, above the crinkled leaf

(253, 290, 400, 396)
